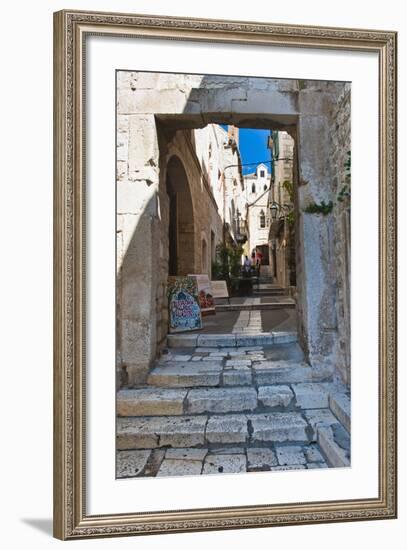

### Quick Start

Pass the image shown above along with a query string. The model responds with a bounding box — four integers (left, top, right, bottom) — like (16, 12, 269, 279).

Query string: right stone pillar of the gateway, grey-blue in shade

(297, 113, 338, 374)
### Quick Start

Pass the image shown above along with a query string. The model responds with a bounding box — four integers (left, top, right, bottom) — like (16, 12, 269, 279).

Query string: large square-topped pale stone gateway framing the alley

(117, 71, 350, 379)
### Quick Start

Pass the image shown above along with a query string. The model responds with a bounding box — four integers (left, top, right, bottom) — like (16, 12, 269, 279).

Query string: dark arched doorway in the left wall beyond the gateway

(166, 155, 195, 275)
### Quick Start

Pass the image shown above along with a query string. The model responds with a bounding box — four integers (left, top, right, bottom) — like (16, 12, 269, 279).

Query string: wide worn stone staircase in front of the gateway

(117, 333, 350, 477)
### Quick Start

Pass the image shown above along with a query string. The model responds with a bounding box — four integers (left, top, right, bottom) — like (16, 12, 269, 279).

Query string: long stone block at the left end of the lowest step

(117, 415, 207, 450)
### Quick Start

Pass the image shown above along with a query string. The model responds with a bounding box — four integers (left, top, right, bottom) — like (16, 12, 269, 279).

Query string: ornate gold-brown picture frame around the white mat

(54, 10, 397, 540)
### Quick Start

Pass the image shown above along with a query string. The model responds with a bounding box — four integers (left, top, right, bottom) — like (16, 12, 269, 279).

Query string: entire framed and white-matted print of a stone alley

(54, 10, 396, 539)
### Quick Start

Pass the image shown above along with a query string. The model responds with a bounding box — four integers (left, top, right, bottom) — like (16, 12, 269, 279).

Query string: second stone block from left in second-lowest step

(186, 387, 257, 414)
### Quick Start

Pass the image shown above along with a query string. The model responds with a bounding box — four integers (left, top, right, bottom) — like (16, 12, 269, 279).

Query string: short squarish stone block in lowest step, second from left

(205, 414, 249, 444)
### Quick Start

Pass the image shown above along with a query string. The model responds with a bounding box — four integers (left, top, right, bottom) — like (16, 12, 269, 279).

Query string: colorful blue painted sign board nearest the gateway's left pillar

(167, 276, 202, 332)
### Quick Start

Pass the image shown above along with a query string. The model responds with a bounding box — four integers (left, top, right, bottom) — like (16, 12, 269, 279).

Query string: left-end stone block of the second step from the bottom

(117, 387, 188, 416)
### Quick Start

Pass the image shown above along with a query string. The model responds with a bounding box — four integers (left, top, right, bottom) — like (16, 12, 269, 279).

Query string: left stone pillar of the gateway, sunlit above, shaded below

(117, 108, 159, 385)
